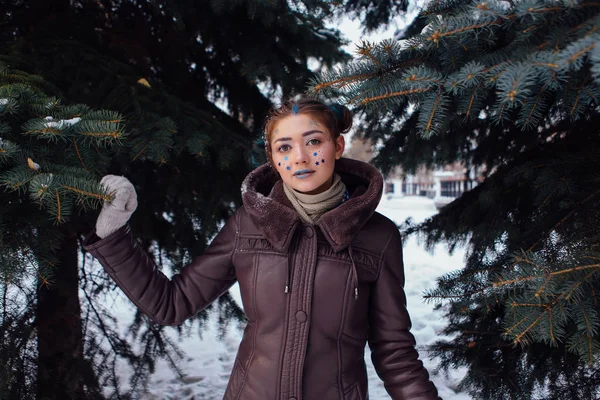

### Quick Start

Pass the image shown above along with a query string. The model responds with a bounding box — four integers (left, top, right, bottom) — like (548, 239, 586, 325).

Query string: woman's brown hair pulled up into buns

(264, 98, 353, 163)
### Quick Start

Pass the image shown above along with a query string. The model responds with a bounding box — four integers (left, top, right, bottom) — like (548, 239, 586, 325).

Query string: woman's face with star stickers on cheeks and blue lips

(269, 114, 344, 194)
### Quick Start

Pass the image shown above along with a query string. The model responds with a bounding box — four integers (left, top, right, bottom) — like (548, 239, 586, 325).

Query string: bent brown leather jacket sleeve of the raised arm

(84, 212, 237, 325)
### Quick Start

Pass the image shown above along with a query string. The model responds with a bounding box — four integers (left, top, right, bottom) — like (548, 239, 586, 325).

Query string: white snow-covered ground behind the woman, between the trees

(113, 197, 470, 400)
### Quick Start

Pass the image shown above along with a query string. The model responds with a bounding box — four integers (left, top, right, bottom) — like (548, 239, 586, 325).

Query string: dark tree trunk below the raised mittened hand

(36, 226, 86, 400)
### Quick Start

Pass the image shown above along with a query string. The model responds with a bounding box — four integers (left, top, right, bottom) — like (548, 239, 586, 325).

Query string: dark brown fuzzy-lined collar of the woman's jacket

(242, 158, 383, 252)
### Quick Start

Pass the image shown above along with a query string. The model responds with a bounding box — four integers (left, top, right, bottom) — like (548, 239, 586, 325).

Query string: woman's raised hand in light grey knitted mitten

(96, 175, 137, 239)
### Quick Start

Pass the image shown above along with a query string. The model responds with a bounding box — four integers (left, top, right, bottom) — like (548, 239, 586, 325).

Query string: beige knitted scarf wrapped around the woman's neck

(283, 174, 346, 225)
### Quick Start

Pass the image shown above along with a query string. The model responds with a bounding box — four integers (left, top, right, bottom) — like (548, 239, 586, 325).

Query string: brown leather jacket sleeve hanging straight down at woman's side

(368, 227, 440, 400)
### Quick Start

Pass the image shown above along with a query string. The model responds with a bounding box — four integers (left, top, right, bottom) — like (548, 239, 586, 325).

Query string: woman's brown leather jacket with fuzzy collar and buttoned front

(85, 159, 439, 400)
